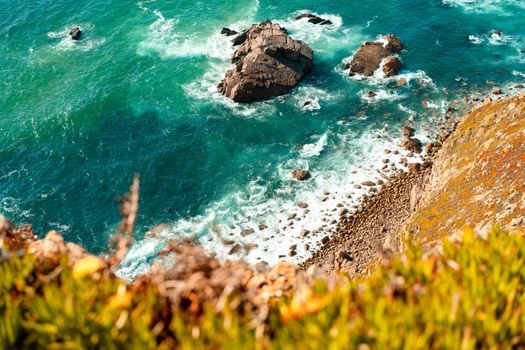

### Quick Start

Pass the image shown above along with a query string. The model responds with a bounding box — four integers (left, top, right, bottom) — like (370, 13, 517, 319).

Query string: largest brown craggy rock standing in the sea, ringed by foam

(218, 21, 314, 102)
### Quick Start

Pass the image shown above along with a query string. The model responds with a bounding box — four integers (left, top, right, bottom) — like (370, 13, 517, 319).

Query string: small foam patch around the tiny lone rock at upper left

(47, 23, 106, 52)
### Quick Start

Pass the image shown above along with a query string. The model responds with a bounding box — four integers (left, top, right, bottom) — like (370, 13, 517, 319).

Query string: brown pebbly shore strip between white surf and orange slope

(300, 89, 524, 276)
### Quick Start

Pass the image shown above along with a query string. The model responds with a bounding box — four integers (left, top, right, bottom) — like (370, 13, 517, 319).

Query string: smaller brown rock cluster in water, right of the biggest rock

(345, 34, 403, 76)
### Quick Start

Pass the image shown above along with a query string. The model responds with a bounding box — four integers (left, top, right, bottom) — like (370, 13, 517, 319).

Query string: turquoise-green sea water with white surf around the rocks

(0, 0, 525, 273)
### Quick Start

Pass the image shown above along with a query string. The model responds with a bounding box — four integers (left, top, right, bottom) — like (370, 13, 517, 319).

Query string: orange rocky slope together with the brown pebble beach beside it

(302, 95, 525, 275)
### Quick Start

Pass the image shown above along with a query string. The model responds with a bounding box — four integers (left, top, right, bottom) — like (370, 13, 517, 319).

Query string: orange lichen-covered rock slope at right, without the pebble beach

(403, 95, 525, 239)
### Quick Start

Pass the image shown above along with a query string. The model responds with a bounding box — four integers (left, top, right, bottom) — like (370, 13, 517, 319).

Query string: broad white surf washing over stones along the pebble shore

(117, 112, 425, 278)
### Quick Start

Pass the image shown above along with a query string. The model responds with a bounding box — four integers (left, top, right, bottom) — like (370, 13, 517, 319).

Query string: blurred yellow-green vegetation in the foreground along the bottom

(0, 229, 525, 349)
